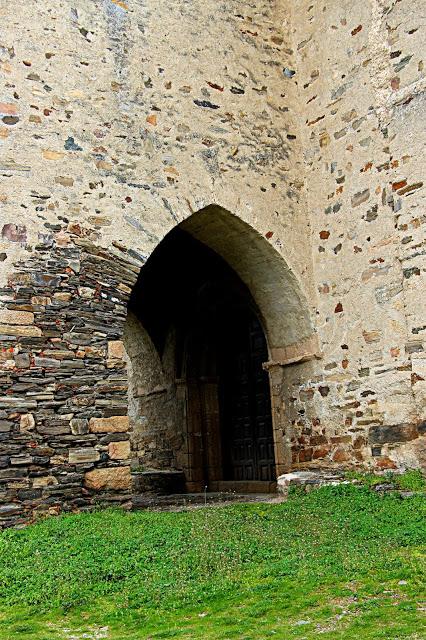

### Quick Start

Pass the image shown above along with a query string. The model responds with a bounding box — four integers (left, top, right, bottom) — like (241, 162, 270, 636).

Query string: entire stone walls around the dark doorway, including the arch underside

(0, 0, 426, 526)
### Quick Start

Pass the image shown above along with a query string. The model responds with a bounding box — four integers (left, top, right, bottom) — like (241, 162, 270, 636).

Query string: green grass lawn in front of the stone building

(0, 485, 426, 640)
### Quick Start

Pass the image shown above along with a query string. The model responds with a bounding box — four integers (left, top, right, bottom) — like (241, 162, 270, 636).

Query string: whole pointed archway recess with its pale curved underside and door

(124, 206, 314, 490)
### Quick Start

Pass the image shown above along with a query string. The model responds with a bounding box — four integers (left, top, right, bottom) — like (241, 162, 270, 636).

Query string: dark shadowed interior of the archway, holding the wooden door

(126, 228, 276, 490)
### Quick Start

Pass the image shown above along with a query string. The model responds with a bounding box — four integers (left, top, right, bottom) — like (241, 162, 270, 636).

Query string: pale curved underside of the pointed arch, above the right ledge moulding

(178, 204, 319, 352)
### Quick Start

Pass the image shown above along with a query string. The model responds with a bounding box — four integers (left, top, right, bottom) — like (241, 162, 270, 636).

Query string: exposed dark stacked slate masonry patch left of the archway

(0, 238, 139, 526)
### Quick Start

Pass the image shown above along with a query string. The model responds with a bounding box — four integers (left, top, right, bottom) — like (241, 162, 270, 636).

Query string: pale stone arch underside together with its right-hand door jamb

(123, 205, 320, 490)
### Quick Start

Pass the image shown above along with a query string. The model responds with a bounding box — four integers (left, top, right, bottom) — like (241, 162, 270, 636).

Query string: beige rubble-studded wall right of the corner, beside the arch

(287, 0, 426, 468)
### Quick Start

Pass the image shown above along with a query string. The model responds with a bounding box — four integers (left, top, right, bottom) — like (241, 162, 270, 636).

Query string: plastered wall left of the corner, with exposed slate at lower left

(0, 0, 314, 523)
